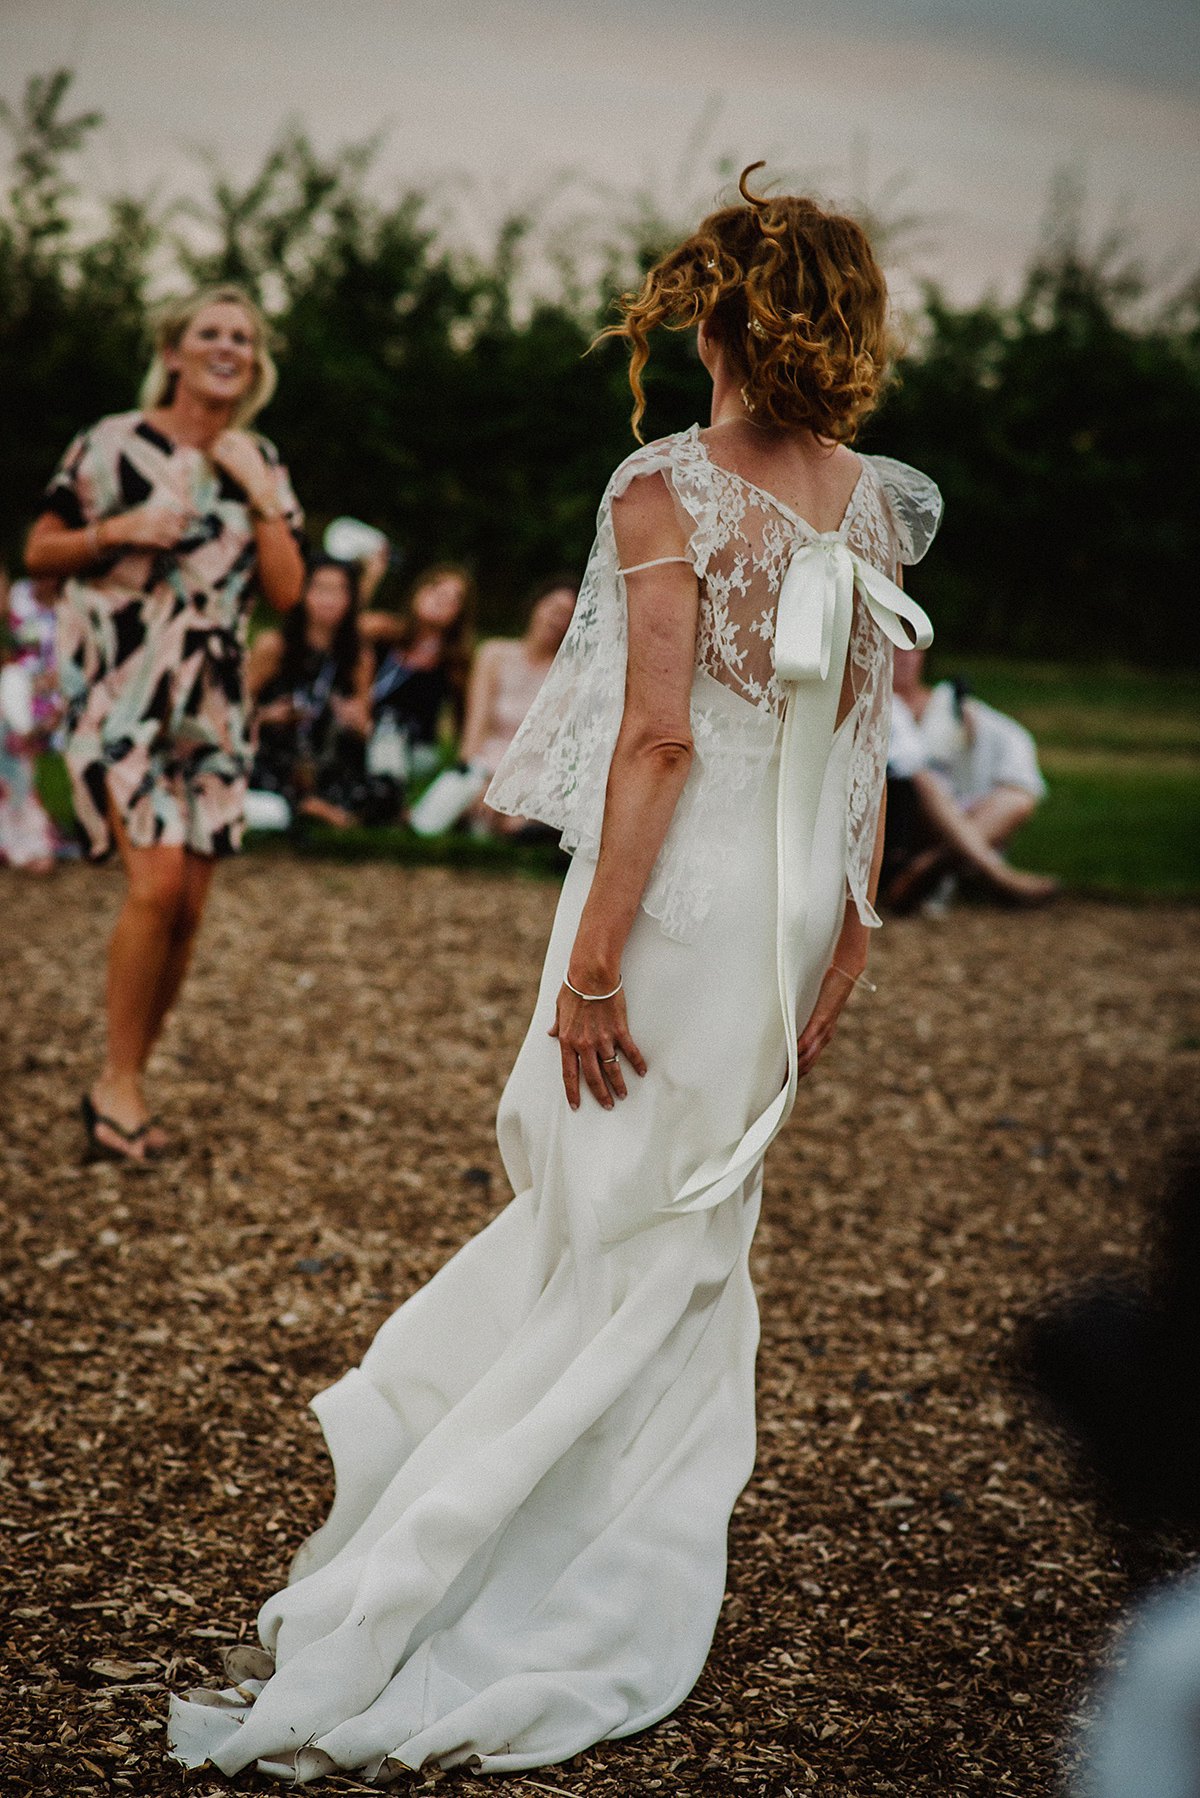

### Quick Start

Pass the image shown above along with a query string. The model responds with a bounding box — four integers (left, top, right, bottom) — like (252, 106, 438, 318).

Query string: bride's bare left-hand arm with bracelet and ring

(551, 475, 700, 1109)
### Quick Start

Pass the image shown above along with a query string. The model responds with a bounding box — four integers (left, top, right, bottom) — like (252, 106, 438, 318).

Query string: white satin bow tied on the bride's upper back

(775, 534, 934, 681)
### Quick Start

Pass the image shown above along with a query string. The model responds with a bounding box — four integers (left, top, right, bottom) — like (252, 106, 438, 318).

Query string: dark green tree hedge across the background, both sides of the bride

(0, 70, 1200, 665)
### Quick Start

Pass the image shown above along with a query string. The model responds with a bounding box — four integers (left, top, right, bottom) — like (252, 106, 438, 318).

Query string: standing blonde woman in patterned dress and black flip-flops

(25, 288, 304, 1160)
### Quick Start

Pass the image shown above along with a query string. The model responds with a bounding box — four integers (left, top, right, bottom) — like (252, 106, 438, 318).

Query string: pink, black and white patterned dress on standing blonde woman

(45, 412, 302, 858)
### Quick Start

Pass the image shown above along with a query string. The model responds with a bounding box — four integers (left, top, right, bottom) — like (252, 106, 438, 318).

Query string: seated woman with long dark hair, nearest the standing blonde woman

(246, 556, 371, 827)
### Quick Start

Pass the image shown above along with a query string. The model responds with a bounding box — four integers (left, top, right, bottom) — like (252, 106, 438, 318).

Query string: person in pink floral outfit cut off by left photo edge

(0, 577, 63, 874)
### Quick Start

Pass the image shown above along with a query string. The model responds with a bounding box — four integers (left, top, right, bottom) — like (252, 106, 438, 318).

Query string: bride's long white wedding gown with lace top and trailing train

(171, 432, 936, 1784)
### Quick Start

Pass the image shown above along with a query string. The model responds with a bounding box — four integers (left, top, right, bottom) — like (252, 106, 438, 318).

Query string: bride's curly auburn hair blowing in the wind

(597, 162, 898, 442)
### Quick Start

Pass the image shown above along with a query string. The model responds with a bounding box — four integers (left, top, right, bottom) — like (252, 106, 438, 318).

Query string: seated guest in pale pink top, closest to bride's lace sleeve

(459, 574, 579, 836)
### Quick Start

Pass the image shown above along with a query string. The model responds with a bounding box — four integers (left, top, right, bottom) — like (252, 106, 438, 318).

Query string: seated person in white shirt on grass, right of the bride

(882, 649, 1058, 912)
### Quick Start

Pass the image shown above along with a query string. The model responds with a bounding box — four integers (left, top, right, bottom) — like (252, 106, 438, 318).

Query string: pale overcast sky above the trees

(0, 0, 1200, 297)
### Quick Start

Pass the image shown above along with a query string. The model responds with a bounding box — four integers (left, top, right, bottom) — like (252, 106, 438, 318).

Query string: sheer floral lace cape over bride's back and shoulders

(488, 426, 941, 940)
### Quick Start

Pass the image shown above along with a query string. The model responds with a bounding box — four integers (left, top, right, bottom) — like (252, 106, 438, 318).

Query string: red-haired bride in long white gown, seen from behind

(171, 165, 941, 1784)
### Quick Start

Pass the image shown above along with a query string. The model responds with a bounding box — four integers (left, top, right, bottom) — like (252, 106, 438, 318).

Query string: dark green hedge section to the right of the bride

(864, 180, 1200, 667)
